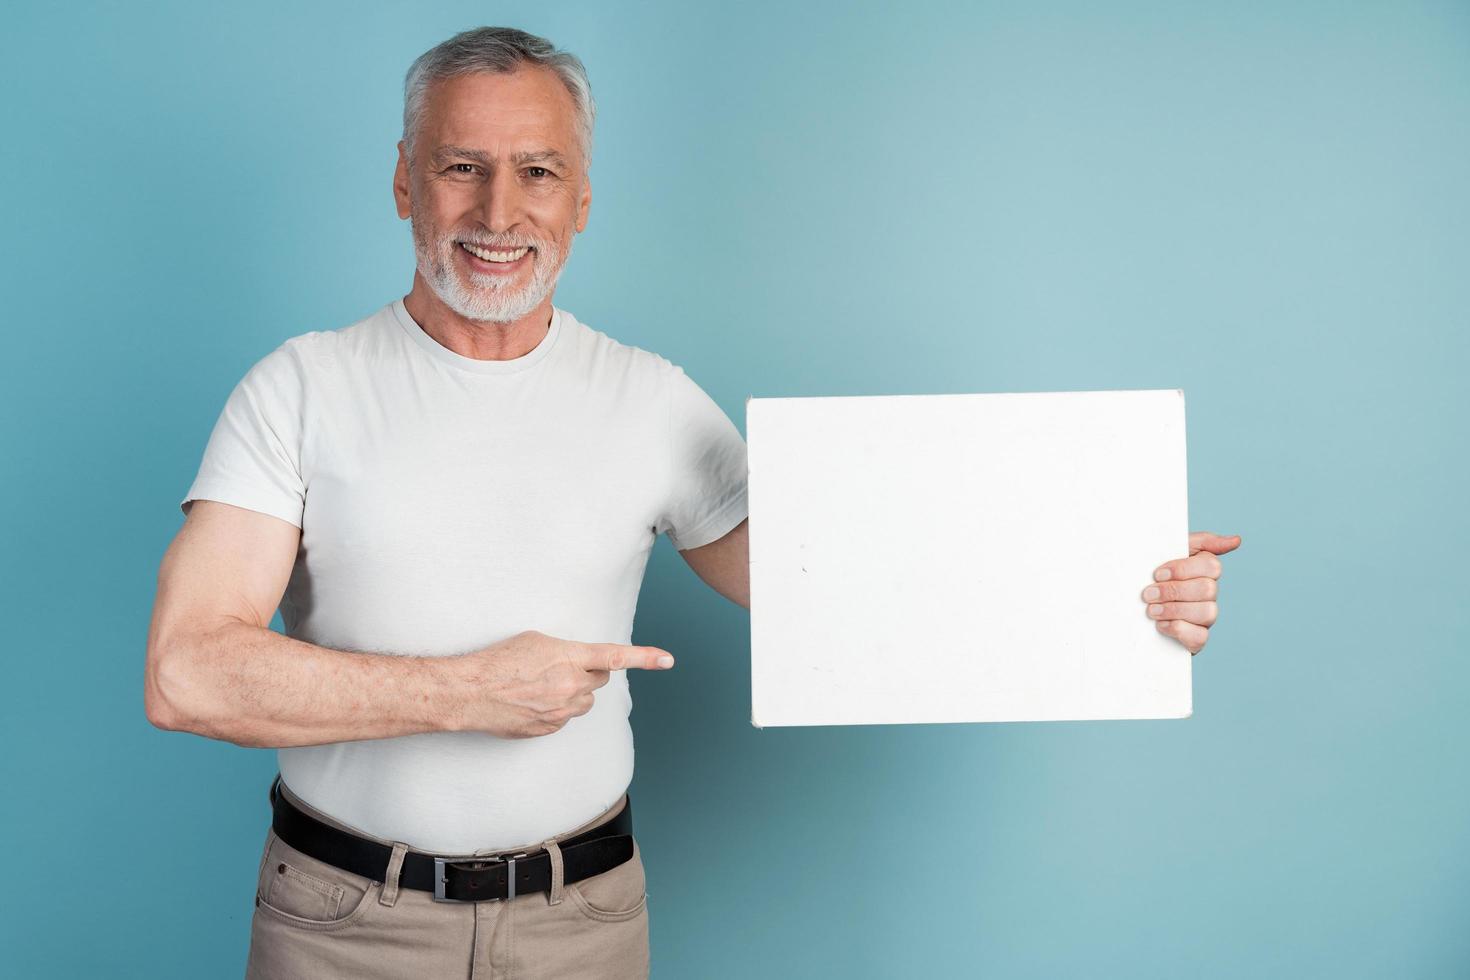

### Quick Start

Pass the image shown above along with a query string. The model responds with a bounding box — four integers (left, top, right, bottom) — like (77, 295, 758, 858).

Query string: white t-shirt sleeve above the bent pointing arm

(179, 344, 306, 527)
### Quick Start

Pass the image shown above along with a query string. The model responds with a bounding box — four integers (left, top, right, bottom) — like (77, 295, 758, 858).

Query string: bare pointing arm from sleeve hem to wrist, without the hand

(144, 500, 473, 748)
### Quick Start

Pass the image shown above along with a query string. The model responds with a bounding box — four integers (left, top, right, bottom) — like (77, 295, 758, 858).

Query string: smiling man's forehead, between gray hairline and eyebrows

(420, 66, 579, 157)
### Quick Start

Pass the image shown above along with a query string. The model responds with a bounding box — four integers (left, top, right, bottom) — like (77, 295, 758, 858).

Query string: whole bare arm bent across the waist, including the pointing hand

(143, 500, 673, 748)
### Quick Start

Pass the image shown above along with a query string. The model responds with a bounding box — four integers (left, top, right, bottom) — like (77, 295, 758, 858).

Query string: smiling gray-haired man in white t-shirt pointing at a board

(146, 28, 1235, 977)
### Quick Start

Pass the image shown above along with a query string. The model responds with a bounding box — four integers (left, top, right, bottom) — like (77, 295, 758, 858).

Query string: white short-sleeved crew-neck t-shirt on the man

(181, 300, 747, 854)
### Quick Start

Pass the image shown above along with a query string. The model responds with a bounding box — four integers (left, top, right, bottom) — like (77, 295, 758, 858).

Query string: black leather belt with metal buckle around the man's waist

(270, 774, 634, 902)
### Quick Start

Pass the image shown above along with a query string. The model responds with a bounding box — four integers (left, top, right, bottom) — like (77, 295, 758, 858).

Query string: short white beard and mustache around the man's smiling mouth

(409, 217, 572, 323)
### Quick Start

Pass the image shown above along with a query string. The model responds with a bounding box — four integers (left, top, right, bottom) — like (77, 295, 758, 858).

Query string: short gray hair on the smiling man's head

(403, 28, 597, 169)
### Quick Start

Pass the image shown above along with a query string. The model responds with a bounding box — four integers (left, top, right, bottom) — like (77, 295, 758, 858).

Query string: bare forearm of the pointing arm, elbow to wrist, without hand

(148, 620, 466, 748)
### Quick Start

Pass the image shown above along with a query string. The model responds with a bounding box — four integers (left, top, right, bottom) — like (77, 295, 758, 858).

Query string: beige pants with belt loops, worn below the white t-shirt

(245, 782, 648, 980)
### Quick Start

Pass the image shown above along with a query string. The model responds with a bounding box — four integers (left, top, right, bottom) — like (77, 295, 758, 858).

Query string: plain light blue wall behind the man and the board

(0, 1, 1470, 977)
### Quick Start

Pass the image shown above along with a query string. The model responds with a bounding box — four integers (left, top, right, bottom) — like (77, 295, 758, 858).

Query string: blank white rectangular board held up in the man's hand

(745, 388, 1192, 727)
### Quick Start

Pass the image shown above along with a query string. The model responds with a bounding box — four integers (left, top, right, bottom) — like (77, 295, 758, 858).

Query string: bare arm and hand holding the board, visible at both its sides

(679, 517, 1241, 654)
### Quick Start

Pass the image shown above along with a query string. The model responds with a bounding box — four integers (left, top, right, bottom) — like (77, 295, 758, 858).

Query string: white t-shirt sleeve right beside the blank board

(657, 366, 747, 551)
